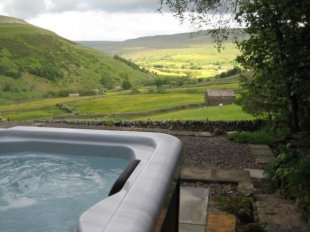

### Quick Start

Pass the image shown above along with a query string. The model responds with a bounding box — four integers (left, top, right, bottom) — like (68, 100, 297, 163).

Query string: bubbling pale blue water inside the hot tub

(0, 152, 128, 232)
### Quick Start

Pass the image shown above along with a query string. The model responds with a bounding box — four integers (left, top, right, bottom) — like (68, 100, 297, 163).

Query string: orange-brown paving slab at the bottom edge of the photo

(207, 214, 237, 232)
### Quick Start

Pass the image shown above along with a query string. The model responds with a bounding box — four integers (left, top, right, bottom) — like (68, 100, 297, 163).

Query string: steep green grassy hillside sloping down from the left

(0, 16, 148, 101)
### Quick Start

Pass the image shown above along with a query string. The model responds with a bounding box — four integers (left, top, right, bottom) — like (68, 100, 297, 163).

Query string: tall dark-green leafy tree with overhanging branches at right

(162, 0, 310, 131)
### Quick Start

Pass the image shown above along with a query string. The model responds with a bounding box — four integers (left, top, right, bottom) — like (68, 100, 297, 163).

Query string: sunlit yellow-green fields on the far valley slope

(122, 43, 239, 78)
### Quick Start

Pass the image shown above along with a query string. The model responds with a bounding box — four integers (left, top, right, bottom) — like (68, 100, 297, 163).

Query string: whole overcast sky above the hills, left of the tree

(0, 0, 199, 40)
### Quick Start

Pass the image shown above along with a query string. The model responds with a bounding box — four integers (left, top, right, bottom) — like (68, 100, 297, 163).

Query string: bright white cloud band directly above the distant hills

(28, 11, 192, 41)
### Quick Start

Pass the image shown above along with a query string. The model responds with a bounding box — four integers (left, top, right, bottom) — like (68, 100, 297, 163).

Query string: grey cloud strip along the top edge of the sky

(0, 0, 160, 18)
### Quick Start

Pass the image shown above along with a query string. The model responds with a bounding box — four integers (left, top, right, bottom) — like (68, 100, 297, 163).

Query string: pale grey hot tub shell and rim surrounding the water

(0, 127, 183, 232)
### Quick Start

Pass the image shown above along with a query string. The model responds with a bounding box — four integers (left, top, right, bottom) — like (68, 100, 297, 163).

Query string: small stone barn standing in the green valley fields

(205, 90, 236, 106)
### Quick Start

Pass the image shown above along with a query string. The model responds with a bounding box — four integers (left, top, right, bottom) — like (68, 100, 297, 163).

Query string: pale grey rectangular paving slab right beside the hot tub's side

(179, 187, 209, 226)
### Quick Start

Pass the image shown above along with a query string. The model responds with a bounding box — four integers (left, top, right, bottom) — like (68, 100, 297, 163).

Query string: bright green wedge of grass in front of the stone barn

(133, 105, 254, 121)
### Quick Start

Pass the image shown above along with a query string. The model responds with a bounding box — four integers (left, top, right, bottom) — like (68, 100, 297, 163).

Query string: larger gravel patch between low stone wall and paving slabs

(178, 136, 255, 169)
